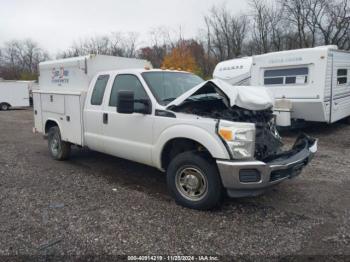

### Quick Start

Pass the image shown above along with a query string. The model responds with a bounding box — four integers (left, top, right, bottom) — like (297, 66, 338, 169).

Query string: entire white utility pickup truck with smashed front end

(33, 56, 317, 209)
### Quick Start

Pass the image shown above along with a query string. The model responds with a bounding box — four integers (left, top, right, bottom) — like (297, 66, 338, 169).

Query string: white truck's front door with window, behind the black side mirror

(103, 74, 154, 165)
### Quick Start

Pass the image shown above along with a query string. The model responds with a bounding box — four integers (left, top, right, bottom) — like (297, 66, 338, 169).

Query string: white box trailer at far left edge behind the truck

(0, 80, 31, 111)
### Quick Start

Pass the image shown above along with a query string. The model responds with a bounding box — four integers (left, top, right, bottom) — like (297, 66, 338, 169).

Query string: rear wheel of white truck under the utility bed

(48, 126, 71, 161)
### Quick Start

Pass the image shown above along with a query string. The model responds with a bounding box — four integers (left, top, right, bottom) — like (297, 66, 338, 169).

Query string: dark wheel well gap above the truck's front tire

(161, 138, 212, 170)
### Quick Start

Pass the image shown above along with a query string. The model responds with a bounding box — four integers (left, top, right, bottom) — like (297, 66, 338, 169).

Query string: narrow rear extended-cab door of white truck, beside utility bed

(84, 75, 110, 152)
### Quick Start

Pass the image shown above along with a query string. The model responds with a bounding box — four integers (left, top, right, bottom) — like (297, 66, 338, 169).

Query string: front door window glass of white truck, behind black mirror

(109, 75, 148, 109)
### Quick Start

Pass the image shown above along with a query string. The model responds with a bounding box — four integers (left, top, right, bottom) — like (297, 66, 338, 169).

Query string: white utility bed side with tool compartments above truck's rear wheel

(33, 90, 86, 146)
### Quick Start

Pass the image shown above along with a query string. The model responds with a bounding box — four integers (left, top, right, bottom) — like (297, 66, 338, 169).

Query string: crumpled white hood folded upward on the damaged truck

(167, 79, 273, 110)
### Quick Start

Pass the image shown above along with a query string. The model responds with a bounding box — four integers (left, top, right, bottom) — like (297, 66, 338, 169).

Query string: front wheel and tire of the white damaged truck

(167, 152, 224, 210)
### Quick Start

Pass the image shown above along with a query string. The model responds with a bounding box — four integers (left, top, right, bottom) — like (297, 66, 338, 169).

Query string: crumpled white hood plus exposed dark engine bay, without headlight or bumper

(168, 80, 290, 161)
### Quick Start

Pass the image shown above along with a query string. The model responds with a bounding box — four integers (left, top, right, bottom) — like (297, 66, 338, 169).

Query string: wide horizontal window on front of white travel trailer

(264, 67, 309, 85)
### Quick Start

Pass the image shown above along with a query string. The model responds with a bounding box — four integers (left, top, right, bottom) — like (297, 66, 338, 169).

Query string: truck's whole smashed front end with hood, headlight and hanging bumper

(168, 80, 317, 197)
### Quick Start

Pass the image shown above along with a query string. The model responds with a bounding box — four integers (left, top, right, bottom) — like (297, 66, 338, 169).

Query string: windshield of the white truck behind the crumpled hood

(142, 72, 204, 105)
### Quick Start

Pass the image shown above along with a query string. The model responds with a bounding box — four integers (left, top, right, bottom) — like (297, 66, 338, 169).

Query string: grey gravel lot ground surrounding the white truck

(0, 110, 350, 256)
